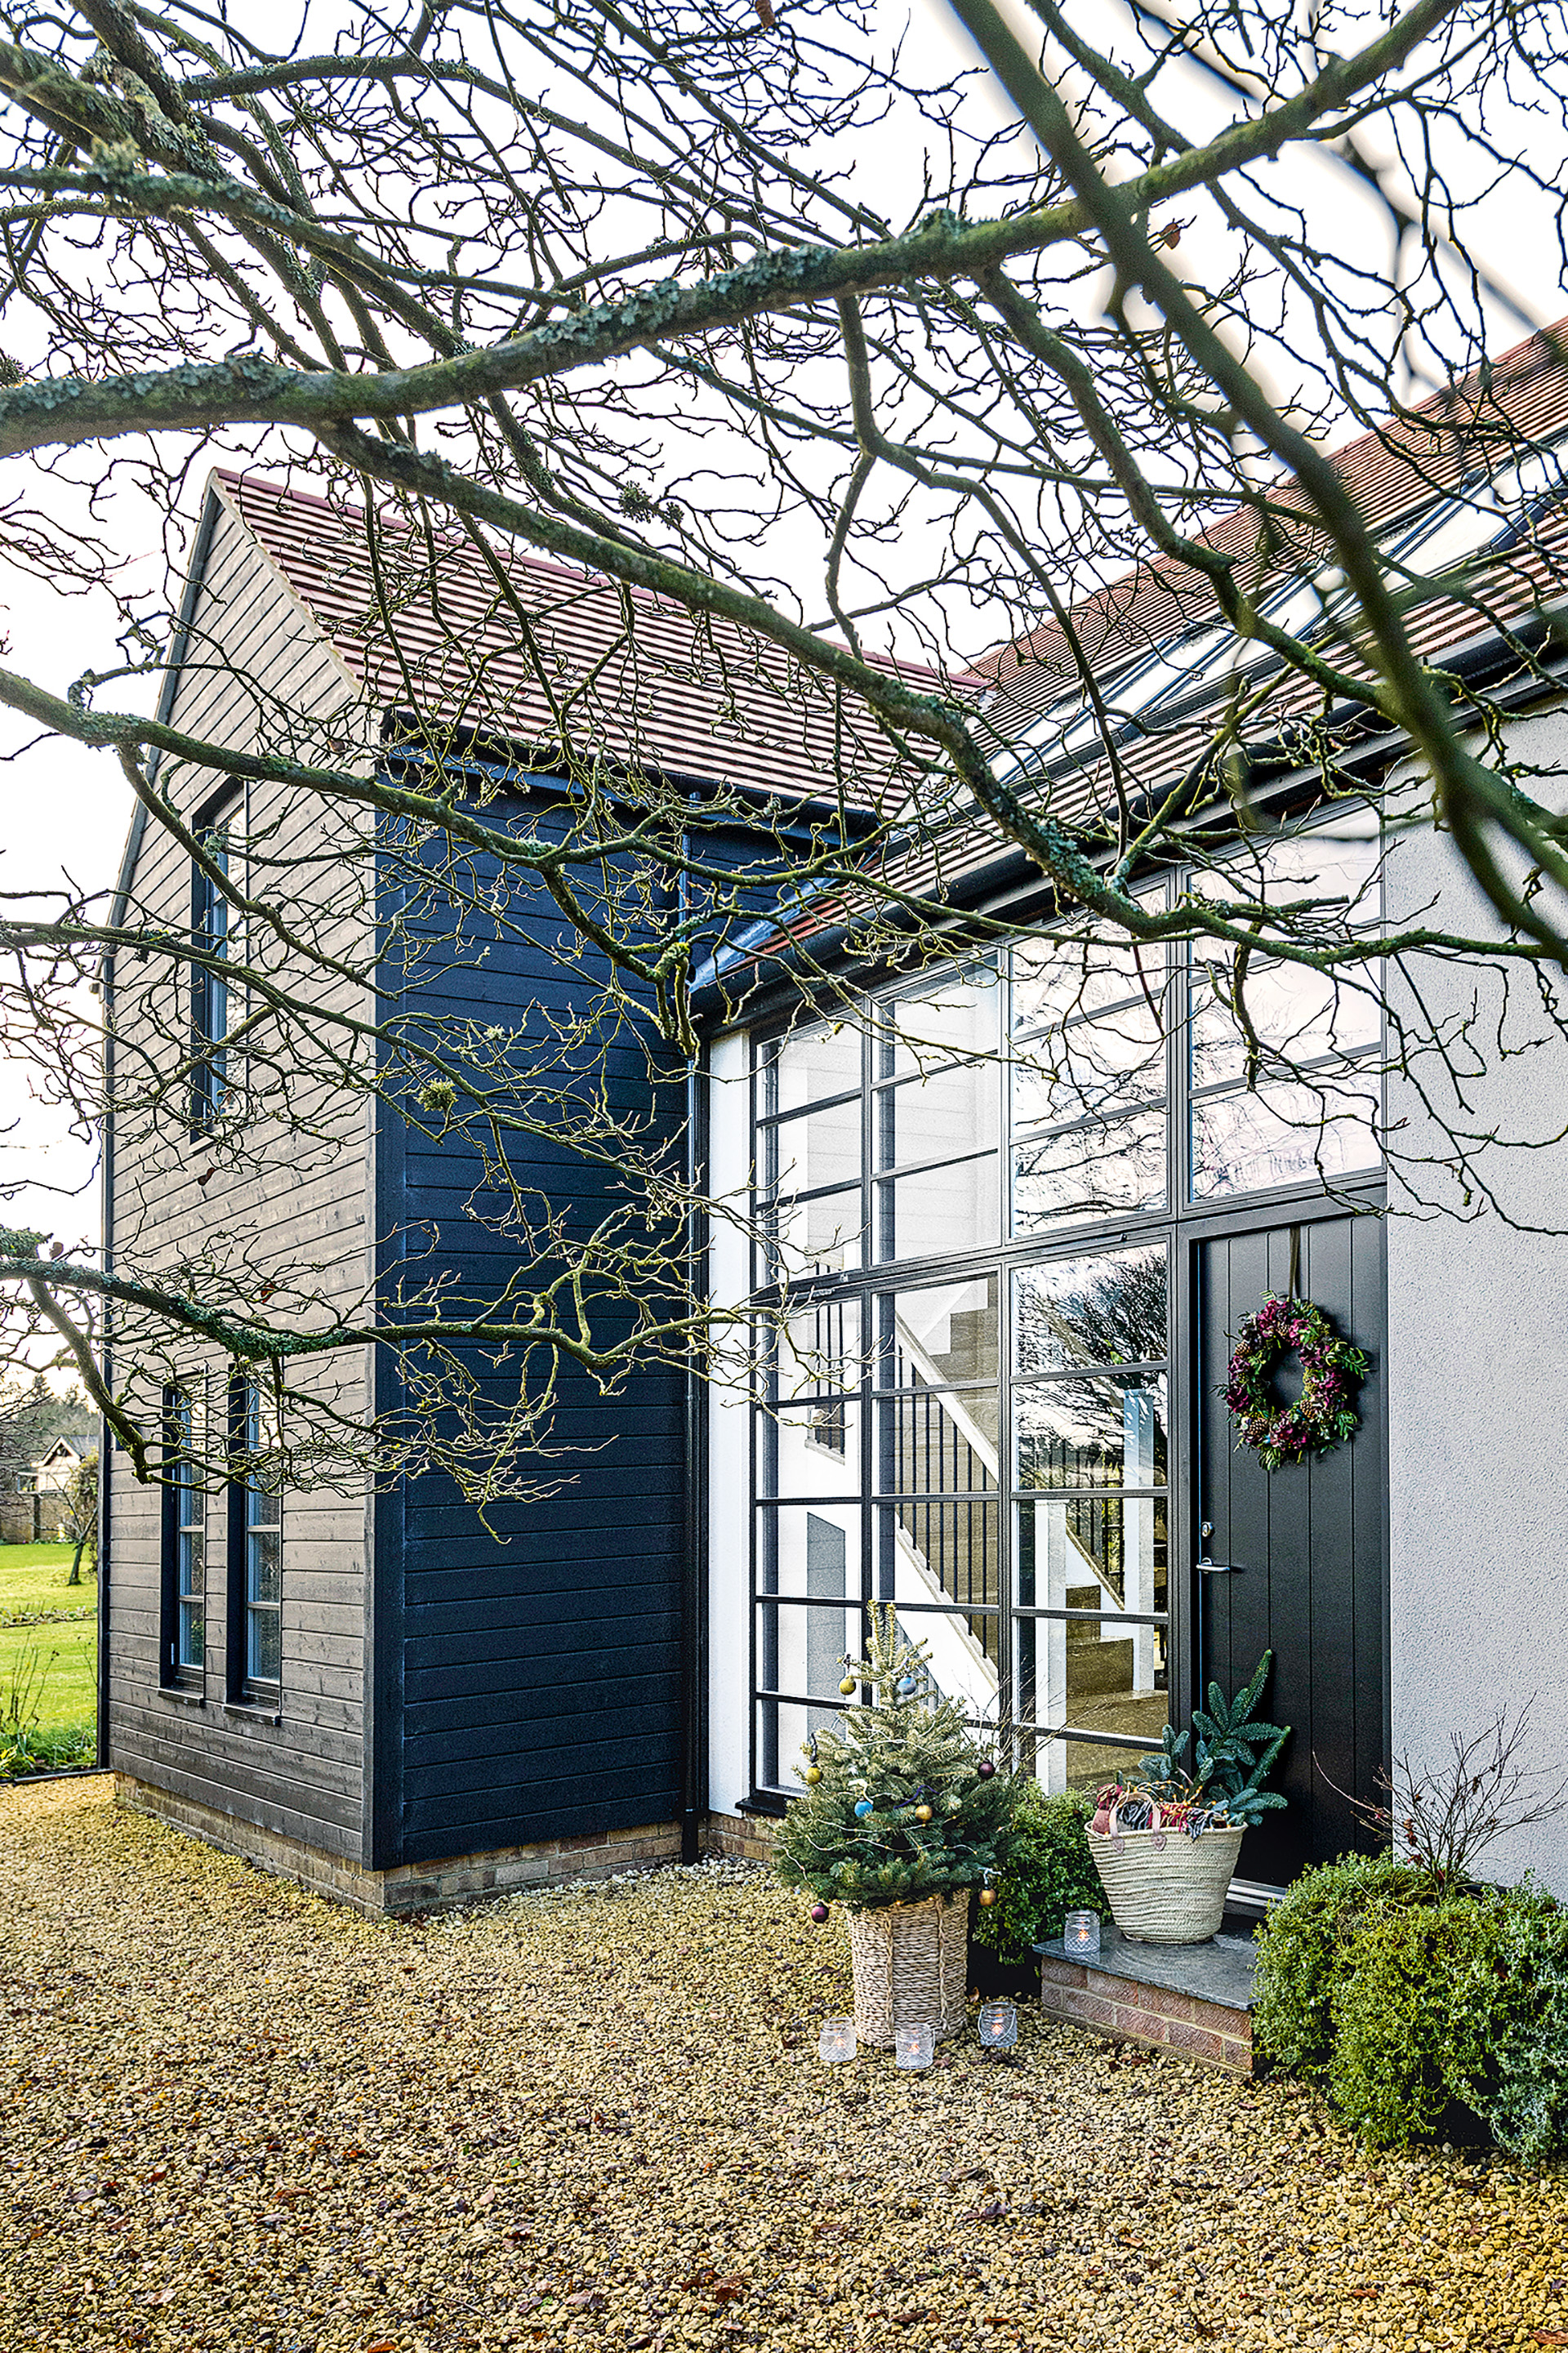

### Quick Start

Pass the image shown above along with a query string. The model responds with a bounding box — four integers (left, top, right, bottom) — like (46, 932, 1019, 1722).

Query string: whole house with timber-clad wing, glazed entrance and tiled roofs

(101, 327, 1568, 1908)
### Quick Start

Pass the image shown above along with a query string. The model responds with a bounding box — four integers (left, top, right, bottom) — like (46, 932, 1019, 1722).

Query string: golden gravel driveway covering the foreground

(0, 1779, 1568, 2353)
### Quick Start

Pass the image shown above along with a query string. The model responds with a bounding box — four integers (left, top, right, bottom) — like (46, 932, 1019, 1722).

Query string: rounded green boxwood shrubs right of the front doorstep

(1253, 1856, 1568, 2160)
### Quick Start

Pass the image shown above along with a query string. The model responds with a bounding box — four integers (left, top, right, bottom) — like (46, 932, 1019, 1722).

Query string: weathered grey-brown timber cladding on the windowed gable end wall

(106, 497, 370, 1856)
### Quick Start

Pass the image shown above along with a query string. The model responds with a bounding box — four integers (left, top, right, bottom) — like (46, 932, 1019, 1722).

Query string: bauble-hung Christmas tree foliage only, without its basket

(774, 1602, 1017, 1910)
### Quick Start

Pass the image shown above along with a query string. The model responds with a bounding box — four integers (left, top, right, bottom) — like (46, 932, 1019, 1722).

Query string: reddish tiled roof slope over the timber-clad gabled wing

(214, 470, 937, 802)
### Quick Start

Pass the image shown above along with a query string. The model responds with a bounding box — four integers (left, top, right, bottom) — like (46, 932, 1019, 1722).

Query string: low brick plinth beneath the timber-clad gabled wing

(115, 1774, 680, 1918)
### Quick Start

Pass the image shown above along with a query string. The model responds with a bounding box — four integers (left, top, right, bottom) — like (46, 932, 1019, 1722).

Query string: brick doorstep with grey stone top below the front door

(1036, 1927, 1253, 2075)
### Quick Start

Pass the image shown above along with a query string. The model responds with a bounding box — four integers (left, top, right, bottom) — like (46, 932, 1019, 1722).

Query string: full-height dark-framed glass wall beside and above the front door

(751, 838, 1379, 1793)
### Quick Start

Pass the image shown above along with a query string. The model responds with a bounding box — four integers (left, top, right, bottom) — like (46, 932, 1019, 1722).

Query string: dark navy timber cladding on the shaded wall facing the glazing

(376, 795, 685, 1864)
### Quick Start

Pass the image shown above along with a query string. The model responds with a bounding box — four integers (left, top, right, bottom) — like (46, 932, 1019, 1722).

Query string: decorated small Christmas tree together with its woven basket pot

(774, 1602, 1015, 2049)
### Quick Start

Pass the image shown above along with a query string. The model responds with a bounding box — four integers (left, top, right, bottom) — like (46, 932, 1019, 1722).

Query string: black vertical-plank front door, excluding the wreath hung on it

(1192, 1214, 1387, 1887)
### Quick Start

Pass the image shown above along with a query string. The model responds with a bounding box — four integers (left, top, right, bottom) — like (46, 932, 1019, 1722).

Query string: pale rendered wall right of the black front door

(1387, 711, 1568, 1896)
